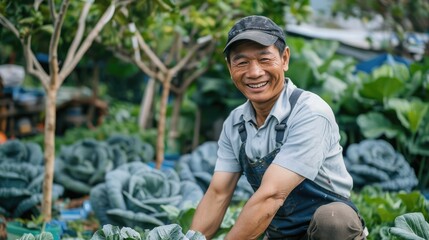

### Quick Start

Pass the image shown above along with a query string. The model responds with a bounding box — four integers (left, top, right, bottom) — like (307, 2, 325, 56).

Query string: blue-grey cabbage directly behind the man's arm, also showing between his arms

(176, 141, 253, 201)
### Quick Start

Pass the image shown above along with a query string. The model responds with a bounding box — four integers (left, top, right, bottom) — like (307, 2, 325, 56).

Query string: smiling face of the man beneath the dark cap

(228, 41, 289, 105)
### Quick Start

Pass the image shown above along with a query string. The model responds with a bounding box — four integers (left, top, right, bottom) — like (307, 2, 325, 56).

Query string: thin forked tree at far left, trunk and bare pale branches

(0, 0, 127, 222)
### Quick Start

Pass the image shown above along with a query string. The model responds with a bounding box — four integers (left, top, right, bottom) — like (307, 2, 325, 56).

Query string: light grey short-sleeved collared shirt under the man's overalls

(215, 79, 353, 197)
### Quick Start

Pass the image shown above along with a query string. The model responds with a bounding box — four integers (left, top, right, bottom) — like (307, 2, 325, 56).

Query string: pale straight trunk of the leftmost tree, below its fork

(42, 89, 57, 222)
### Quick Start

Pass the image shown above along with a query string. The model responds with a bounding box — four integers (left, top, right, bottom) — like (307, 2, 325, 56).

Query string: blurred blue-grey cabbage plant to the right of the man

(345, 139, 418, 191)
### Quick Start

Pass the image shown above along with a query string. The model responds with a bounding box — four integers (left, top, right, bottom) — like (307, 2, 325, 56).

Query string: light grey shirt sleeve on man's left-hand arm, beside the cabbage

(215, 121, 241, 172)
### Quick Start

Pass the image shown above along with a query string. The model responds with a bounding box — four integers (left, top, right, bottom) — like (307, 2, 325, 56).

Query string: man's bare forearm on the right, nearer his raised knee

(225, 164, 304, 240)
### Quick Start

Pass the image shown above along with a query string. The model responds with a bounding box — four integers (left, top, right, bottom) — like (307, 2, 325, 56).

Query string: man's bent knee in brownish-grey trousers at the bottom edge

(307, 202, 365, 240)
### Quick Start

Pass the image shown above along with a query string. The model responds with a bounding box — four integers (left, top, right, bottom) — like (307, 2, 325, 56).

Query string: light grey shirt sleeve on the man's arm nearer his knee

(273, 110, 332, 180)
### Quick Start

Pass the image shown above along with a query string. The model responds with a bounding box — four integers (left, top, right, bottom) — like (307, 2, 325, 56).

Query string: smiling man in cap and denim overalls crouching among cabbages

(191, 16, 365, 240)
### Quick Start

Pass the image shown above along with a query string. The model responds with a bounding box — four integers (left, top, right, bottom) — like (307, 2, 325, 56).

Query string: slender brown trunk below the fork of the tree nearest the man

(155, 71, 172, 169)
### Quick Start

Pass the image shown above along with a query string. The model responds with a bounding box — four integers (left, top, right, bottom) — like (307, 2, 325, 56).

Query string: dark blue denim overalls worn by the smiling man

(238, 89, 357, 239)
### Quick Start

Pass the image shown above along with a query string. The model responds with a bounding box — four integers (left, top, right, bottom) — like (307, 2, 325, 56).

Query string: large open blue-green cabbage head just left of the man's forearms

(90, 162, 203, 229)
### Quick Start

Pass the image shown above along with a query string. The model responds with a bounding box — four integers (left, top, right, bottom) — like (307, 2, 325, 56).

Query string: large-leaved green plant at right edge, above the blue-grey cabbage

(357, 59, 429, 188)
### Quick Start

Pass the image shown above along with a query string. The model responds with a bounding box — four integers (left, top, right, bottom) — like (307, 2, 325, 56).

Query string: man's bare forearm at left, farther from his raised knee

(191, 172, 241, 239)
